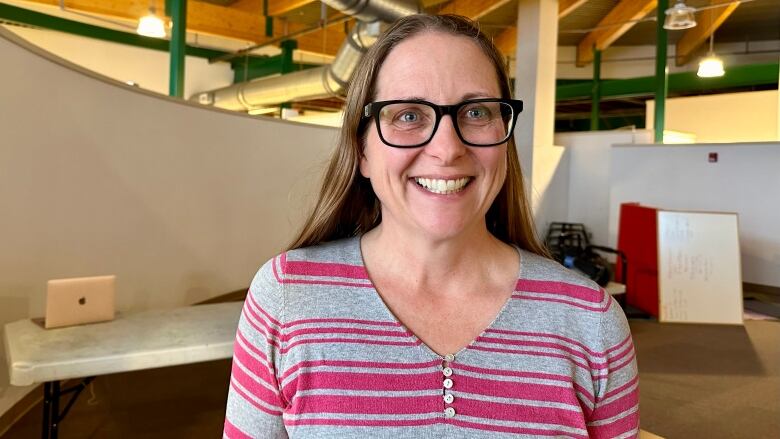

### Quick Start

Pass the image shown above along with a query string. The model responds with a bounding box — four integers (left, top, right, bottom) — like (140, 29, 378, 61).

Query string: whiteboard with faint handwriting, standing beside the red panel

(658, 210, 742, 325)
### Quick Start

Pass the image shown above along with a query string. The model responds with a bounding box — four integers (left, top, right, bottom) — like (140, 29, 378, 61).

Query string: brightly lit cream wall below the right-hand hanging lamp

(645, 90, 780, 143)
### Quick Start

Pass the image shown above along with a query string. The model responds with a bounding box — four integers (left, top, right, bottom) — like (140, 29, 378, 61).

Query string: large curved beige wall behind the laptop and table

(0, 29, 336, 420)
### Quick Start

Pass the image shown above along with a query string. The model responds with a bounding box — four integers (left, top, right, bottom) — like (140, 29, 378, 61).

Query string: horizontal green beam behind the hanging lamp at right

(555, 63, 780, 101)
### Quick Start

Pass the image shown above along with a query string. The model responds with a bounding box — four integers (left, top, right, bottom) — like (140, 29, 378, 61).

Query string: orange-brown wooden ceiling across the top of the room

(13, 0, 780, 65)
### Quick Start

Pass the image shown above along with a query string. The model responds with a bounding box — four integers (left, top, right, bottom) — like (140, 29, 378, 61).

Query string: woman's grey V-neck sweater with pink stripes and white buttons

(224, 238, 639, 439)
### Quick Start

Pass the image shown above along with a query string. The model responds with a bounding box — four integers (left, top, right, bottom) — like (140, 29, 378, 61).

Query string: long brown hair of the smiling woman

(289, 14, 548, 256)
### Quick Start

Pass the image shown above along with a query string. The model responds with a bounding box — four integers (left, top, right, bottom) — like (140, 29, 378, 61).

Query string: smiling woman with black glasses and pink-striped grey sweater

(225, 15, 639, 438)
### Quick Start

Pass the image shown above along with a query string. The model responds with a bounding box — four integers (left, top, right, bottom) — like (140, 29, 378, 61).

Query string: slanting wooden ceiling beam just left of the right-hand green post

(577, 0, 658, 67)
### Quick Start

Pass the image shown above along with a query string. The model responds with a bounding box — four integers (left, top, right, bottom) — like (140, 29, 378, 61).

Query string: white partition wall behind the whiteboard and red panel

(609, 142, 780, 287)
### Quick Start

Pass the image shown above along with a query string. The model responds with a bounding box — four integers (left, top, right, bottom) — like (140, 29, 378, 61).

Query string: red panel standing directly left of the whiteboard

(615, 203, 658, 317)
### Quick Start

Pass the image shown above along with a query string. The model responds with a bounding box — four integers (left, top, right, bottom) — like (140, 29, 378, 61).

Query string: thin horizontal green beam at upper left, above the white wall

(0, 3, 247, 59)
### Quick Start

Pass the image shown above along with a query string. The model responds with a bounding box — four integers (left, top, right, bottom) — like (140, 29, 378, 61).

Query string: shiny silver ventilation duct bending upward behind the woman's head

(191, 0, 417, 111)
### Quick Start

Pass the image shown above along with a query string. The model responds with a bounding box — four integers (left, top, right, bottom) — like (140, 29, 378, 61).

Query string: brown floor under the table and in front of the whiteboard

(2, 320, 780, 439)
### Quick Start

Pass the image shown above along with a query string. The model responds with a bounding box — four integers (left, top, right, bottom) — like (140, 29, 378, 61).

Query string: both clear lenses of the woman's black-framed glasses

(379, 102, 513, 146)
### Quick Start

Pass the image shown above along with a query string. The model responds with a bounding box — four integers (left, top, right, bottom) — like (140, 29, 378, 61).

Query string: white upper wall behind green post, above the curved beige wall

(3, 26, 233, 97)
